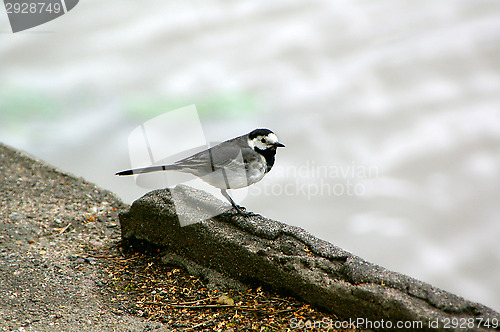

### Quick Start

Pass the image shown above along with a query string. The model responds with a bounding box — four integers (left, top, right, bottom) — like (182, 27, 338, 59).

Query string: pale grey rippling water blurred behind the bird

(0, 0, 500, 310)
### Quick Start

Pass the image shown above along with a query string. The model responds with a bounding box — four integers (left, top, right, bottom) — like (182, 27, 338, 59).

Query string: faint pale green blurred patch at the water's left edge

(0, 87, 62, 123)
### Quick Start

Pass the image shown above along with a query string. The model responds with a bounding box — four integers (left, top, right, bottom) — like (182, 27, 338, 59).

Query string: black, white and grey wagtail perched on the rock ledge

(116, 129, 285, 215)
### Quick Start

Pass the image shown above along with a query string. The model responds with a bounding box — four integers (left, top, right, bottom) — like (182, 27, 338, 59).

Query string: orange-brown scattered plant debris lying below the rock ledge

(96, 241, 352, 331)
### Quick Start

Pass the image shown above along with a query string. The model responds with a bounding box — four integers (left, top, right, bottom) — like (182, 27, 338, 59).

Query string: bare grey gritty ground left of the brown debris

(0, 143, 165, 332)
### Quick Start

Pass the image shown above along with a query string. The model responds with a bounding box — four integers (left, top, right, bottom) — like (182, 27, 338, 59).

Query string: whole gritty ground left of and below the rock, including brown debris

(0, 144, 354, 332)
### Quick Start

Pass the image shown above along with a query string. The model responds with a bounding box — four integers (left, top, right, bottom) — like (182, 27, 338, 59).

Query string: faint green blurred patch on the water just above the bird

(124, 93, 260, 121)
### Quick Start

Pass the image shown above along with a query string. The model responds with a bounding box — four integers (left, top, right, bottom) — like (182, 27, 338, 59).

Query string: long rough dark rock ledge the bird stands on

(120, 186, 500, 331)
